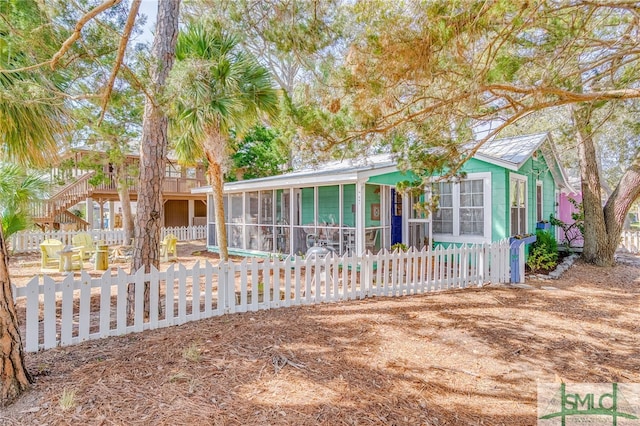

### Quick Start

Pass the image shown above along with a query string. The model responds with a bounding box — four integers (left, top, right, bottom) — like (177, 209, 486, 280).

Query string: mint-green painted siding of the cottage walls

(202, 136, 558, 252)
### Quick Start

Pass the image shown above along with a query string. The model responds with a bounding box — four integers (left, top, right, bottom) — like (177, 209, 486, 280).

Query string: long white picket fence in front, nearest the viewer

(14, 241, 509, 352)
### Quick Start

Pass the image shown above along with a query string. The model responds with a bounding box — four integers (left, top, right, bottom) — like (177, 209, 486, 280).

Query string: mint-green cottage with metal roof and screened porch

(193, 133, 572, 255)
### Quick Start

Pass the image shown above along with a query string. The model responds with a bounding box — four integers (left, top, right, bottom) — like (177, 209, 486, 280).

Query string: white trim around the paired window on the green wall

(432, 172, 493, 243)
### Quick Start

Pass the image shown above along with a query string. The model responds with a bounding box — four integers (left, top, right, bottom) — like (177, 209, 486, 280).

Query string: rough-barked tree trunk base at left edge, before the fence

(0, 227, 32, 407)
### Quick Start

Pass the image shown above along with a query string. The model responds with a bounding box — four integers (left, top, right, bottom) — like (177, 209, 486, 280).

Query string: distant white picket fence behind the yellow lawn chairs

(9, 225, 207, 253)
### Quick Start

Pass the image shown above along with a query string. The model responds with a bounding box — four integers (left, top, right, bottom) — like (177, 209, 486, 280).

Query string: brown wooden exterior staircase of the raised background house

(32, 171, 94, 230)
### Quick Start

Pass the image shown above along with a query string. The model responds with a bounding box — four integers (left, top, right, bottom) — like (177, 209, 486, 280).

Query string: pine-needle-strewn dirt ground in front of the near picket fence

(0, 247, 640, 425)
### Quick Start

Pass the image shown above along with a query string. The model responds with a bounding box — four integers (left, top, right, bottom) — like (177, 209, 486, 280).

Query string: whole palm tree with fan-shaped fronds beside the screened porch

(170, 23, 278, 261)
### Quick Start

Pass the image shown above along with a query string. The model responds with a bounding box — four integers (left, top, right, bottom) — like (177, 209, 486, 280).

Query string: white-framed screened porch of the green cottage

(194, 155, 431, 255)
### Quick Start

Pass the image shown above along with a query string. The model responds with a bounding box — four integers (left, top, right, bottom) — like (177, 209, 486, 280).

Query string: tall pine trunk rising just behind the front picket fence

(128, 0, 180, 318)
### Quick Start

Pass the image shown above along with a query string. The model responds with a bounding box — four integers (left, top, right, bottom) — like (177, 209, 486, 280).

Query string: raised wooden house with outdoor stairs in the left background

(33, 148, 206, 230)
